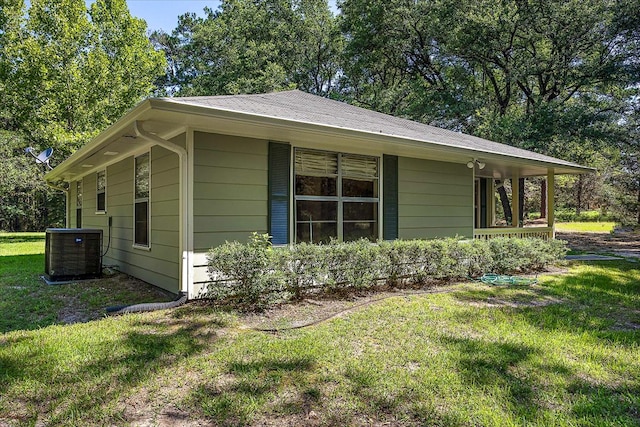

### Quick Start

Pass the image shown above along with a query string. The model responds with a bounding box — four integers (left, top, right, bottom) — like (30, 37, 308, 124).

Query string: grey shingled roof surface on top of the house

(169, 90, 587, 169)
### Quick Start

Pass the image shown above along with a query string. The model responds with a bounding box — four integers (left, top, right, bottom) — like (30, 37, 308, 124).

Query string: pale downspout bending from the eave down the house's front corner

(133, 120, 192, 298)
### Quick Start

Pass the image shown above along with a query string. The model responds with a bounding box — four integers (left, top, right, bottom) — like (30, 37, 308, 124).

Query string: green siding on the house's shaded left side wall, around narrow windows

(79, 140, 185, 293)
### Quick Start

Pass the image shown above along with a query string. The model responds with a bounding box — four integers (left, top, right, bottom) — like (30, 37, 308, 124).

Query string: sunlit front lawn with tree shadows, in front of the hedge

(0, 236, 640, 426)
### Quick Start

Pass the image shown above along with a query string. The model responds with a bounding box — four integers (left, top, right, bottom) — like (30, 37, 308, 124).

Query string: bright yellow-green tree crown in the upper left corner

(7, 0, 165, 155)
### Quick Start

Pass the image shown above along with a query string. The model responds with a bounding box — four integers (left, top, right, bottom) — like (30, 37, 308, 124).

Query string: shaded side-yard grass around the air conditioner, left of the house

(0, 233, 173, 333)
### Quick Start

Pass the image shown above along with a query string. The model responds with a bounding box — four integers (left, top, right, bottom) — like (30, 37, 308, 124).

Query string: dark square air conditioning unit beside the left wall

(44, 228, 102, 281)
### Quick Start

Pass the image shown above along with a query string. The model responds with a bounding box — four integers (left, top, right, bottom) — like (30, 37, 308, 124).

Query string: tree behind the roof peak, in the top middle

(152, 0, 342, 95)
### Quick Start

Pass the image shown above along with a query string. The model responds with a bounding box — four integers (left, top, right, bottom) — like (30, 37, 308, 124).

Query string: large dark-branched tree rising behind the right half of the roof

(339, 0, 640, 216)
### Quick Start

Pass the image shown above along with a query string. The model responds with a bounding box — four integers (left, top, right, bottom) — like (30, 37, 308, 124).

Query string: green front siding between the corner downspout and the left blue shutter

(193, 132, 269, 251)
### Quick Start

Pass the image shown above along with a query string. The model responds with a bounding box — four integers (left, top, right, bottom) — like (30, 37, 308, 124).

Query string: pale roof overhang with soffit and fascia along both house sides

(45, 98, 593, 182)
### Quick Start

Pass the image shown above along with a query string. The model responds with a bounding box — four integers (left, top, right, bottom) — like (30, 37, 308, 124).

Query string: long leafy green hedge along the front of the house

(206, 233, 566, 306)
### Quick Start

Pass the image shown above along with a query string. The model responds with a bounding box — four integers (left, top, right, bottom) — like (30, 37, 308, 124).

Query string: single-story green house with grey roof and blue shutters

(45, 90, 590, 298)
